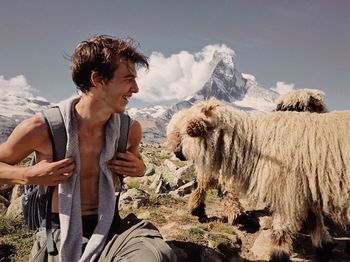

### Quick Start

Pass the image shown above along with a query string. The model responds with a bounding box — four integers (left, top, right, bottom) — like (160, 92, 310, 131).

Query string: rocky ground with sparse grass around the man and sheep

(0, 145, 350, 262)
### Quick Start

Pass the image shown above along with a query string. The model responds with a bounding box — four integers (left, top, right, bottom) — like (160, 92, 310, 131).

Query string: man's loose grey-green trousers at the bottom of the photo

(29, 215, 176, 262)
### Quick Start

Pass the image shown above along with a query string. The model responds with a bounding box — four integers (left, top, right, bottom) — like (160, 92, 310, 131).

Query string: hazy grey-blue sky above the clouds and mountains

(0, 0, 350, 110)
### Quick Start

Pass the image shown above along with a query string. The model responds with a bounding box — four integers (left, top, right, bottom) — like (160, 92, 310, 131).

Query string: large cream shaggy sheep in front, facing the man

(167, 101, 350, 260)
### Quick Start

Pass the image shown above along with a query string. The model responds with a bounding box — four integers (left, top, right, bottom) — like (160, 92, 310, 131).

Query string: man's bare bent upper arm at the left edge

(0, 115, 49, 164)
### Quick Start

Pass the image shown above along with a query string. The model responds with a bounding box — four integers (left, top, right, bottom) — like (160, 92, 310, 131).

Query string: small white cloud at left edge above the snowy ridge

(0, 75, 37, 97)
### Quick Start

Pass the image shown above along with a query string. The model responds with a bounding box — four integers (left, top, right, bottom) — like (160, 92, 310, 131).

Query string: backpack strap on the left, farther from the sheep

(41, 106, 67, 255)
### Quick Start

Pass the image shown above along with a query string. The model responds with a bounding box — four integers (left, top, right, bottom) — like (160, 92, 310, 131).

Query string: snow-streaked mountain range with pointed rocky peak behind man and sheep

(0, 51, 278, 143)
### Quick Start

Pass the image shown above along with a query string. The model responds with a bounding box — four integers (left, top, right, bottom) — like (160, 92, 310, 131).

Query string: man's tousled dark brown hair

(71, 35, 149, 93)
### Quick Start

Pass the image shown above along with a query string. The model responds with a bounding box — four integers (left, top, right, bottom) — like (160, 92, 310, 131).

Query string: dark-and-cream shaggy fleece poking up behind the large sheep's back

(275, 89, 328, 113)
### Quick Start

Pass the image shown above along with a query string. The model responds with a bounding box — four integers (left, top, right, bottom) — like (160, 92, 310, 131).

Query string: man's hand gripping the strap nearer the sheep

(107, 152, 145, 177)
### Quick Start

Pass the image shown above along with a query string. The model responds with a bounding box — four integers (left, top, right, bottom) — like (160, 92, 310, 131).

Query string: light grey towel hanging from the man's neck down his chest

(58, 97, 120, 262)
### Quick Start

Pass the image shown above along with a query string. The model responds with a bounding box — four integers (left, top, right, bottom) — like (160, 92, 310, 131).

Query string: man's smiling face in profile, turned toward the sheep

(104, 60, 139, 113)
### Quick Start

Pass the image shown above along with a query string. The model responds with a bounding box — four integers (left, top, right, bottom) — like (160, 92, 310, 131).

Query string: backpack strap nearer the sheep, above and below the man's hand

(115, 114, 131, 218)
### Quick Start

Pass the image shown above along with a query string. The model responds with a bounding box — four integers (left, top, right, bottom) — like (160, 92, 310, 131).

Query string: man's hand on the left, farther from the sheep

(24, 158, 74, 186)
